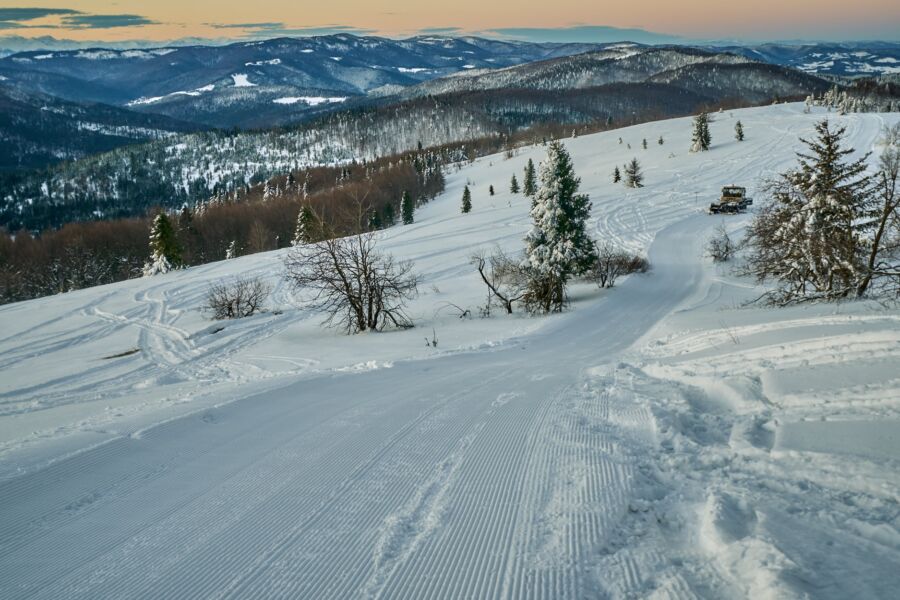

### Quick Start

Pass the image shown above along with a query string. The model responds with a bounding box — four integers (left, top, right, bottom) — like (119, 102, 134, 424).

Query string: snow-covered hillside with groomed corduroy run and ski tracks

(0, 104, 900, 599)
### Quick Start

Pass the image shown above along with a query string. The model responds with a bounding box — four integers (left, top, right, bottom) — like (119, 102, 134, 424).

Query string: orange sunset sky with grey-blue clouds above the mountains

(0, 0, 900, 43)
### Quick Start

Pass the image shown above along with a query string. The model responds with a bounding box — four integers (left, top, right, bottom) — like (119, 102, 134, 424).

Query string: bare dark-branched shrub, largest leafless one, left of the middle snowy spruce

(285, 233, 419, 334)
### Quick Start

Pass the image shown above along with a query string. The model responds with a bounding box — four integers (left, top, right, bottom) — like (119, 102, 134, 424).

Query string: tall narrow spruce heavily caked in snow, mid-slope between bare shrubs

(523, 141, 596, 312)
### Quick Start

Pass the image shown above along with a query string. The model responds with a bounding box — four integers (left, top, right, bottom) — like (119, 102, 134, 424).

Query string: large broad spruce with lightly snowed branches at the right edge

(746, 120, 874, 306)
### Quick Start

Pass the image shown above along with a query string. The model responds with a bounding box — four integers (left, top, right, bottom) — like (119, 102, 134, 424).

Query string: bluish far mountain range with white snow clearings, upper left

(0, 34, 598, 127)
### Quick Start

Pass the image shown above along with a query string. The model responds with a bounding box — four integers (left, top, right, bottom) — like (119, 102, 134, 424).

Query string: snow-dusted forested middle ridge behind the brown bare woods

(0, 44, 832, 228)
